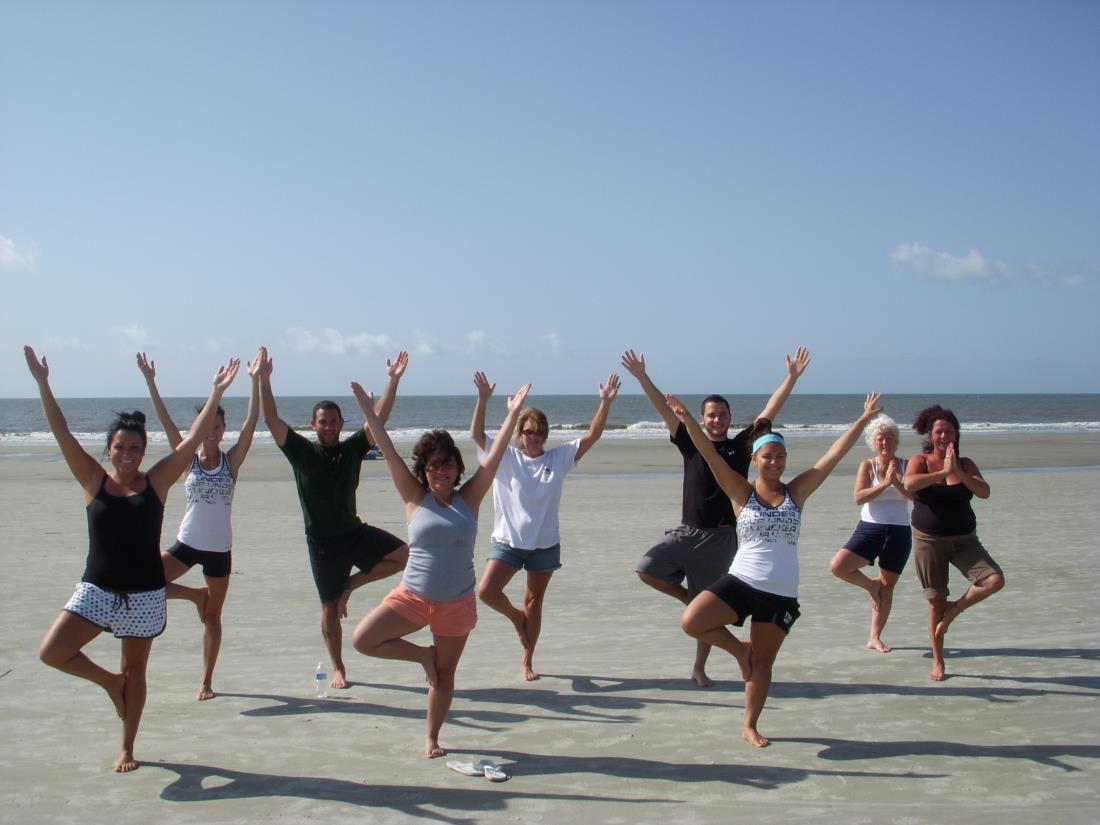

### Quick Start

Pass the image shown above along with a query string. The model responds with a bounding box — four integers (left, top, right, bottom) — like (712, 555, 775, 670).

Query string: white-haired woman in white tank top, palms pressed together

(829, 416, 913, 653)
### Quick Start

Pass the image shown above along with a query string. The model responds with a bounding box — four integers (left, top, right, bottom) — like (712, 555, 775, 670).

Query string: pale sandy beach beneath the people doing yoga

(0, 433, 1100, 825)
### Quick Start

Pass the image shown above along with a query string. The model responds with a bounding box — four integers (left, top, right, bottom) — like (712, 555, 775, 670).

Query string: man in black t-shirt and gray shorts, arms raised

(623, 347, 810, 688)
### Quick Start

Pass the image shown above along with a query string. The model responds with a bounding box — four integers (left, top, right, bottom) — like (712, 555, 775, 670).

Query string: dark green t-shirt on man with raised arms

(279, 429, 371, 538)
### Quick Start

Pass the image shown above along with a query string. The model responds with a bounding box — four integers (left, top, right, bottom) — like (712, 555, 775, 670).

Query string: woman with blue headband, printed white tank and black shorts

(668, 393, 882, 748)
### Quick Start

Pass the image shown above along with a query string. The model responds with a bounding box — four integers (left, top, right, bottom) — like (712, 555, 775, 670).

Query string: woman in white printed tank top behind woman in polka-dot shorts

(138, 352, 260, 701)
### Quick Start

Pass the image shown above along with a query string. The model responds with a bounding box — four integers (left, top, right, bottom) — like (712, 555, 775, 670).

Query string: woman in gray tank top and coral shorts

(351, 382, 531, 759)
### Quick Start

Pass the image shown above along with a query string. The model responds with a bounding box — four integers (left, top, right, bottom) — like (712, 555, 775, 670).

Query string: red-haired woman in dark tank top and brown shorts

(905, 404, 1004, 682)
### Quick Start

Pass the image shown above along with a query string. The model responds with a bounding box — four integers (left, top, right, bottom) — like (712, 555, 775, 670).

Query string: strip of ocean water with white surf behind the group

(0, 393, 1100, 446)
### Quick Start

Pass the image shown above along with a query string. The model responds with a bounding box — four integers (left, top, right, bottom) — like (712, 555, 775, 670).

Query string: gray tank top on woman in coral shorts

(405, 492, 477, 602)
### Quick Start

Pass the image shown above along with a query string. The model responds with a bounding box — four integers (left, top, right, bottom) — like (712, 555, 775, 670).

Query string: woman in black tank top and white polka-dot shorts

(23, 347, 240, 773)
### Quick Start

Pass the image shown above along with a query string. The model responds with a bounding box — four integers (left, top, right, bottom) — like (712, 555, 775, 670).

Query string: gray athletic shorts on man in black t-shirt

(635, 525, 737, 597)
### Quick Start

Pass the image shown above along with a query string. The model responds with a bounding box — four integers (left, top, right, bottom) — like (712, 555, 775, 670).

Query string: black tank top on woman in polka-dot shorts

(81, 475, 164, 593)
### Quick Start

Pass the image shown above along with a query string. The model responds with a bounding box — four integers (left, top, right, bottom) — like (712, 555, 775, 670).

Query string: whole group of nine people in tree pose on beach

(24, 347, 1004, 771)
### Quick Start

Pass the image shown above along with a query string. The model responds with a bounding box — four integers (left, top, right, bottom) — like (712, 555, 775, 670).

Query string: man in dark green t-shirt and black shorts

(260, 348, 409, 689)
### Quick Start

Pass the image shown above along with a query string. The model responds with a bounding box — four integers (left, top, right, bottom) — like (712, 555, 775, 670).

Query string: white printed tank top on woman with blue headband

(729, 488, 802, 598)
